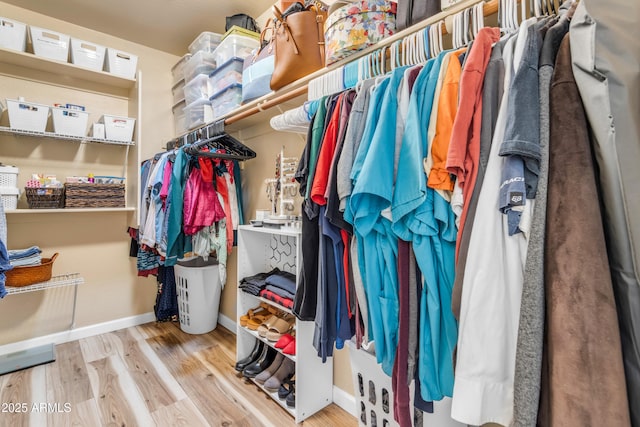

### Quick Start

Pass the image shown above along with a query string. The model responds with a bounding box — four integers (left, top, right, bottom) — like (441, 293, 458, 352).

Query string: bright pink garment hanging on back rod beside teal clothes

(183, 167, 225, 236)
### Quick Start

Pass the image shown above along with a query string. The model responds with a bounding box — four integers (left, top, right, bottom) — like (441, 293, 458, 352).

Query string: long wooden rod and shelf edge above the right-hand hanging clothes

(224, 0, 499, 125)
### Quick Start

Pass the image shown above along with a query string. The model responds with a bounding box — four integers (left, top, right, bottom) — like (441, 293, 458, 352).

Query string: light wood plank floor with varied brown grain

(0, 323, 358, 427)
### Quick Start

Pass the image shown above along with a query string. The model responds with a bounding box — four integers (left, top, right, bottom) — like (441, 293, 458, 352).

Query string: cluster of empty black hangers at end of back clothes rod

(184, 120, 256, 160)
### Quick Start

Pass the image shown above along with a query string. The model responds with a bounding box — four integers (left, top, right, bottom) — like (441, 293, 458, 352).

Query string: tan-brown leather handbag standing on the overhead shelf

(271, 2, 327, 90)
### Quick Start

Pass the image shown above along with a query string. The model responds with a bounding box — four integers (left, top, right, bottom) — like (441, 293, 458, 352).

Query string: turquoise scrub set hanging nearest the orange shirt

(392, 52, 457, 400)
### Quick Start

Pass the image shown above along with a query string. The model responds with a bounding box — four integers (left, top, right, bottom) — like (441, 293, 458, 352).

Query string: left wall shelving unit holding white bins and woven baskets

(0, 48, 141, 213)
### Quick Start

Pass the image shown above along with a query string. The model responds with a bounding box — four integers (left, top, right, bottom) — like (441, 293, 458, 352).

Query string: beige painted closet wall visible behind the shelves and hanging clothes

(0, 2, 353, 402)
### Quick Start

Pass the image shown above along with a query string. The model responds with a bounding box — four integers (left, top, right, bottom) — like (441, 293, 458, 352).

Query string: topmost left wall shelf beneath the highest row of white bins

(0, 48, 136, 97)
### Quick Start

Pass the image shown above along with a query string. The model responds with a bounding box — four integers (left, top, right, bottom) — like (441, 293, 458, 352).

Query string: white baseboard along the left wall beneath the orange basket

(0, 312, 156, 355)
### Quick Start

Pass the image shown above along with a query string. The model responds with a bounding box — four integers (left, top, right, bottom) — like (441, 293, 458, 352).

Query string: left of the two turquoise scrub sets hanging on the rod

(350, 67, 407, 375)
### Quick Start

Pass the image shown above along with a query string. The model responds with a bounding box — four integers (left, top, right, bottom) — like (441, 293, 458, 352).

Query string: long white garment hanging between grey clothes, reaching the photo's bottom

(451, 27, 526, 425)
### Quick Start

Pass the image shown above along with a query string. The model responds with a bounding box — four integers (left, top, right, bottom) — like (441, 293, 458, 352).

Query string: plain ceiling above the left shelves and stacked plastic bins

(3, 0, 274, 56)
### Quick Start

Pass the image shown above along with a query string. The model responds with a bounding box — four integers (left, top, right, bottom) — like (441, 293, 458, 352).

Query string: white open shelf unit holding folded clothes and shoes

(236, 226, 333, 423)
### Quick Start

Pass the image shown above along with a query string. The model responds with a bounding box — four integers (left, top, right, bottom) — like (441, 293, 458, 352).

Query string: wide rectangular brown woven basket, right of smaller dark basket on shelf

(65, 183, 125, 208)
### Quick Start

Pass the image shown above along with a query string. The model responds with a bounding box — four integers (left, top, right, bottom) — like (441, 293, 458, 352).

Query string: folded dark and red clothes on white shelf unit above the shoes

(238, 268, 296, 308)
